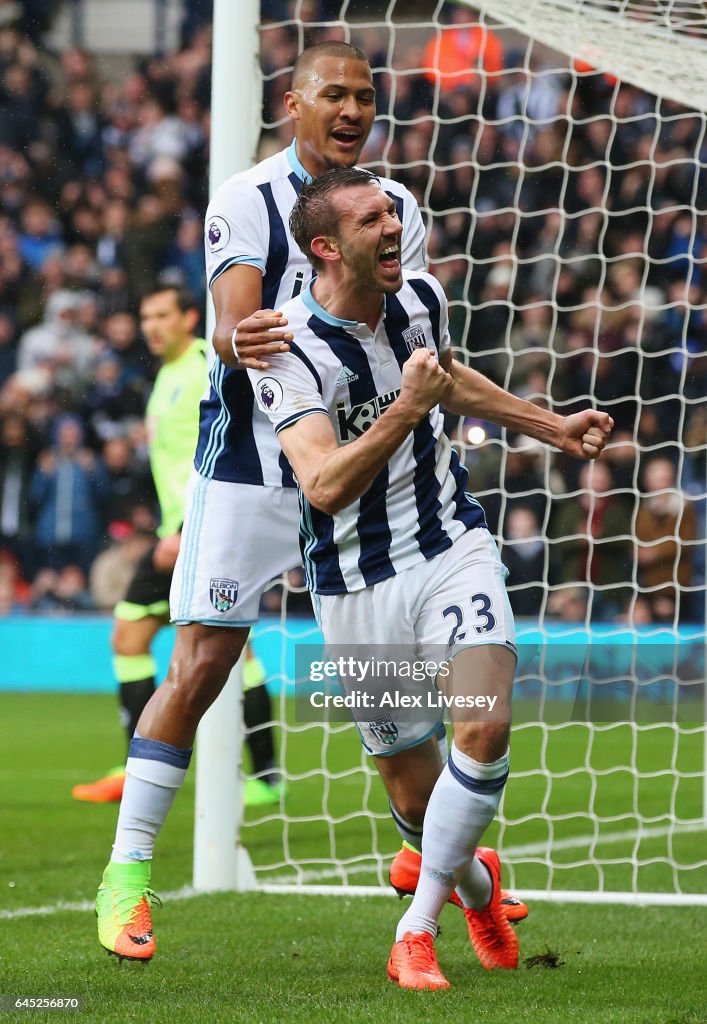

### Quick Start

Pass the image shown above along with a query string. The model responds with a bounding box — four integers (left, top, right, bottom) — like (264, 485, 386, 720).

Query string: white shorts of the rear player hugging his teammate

(169, 470, 301, 626)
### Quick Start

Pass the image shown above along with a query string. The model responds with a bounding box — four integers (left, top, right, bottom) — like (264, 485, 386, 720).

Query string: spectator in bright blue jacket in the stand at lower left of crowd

(30, 415, 107, 573)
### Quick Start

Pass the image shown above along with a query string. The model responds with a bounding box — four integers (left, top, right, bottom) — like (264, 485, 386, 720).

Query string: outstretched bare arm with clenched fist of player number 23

(441, 352, 614, 459)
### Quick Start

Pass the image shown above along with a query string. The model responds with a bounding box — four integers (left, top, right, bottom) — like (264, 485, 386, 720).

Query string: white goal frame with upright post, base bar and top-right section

(194, 0, 707, 906)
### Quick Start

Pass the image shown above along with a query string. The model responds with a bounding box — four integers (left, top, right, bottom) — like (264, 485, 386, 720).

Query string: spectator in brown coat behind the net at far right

(635, 457, 697, 622)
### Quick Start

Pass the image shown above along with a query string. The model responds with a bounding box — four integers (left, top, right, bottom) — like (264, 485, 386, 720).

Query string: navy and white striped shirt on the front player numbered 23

(248, 271, 486, 594)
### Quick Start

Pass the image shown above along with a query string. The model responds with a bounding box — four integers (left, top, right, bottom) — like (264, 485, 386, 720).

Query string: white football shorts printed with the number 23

(314, 527, 515, 757)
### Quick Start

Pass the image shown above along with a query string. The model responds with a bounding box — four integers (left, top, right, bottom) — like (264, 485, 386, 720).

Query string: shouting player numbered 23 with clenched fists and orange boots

(249, 168, 613, 988)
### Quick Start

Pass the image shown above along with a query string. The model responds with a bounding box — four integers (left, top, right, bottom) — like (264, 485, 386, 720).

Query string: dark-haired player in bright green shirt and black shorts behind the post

(72, 287, 280, 804)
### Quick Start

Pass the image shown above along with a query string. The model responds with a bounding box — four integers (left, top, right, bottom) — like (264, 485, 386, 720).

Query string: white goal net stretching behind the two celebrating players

(204, 0, 707, 902)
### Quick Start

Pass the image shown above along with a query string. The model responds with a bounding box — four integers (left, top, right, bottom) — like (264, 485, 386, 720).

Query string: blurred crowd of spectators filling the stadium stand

(0, 2, 707, 625)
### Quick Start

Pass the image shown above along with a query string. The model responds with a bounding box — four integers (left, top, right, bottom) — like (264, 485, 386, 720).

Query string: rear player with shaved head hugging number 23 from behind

(97, 42, 439, 959)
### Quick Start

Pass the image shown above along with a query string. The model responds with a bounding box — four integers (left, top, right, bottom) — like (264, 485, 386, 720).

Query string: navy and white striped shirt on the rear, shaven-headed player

(195, 142, 425, 486)
